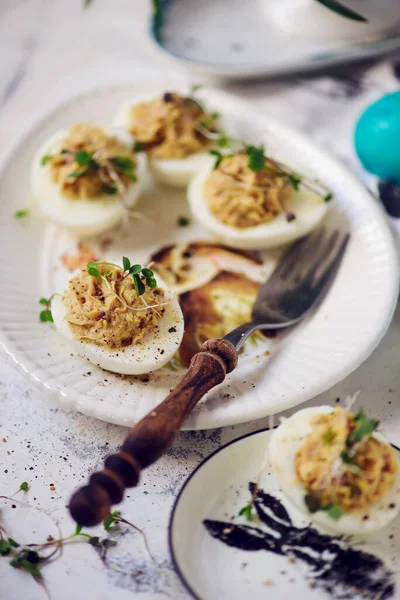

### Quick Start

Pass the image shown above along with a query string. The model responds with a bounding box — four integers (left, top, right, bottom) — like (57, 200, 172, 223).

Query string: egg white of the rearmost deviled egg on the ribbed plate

(114, 95, 210, 188)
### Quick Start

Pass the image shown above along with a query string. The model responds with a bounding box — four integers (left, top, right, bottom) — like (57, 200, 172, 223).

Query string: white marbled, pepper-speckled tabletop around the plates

(0, 0, 400, 600)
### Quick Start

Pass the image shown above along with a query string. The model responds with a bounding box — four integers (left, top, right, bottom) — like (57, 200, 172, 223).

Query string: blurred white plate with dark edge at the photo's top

(150, 0, 400, 79)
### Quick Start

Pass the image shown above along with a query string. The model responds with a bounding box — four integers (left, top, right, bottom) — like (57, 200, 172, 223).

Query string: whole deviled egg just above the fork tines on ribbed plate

(188, 146, 332, 250)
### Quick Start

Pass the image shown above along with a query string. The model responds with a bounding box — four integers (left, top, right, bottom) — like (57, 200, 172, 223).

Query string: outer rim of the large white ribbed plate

(0, 82, 399, 429)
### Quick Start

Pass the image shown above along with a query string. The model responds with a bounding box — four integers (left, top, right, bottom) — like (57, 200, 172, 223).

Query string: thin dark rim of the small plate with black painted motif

(168, 425, 400, 600)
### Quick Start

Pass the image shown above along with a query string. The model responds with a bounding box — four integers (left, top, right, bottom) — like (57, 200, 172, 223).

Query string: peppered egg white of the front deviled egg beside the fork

(51, 276, 184, 375)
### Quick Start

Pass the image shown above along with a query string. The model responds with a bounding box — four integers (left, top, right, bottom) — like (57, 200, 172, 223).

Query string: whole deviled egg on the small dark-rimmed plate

(269, 406, 400, 534)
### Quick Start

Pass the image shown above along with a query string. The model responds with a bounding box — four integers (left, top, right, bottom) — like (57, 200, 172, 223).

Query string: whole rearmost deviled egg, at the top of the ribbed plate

(114, 92, 219, 187)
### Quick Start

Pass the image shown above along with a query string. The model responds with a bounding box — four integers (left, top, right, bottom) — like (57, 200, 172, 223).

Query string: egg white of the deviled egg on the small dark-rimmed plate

(269, 406, 400, 535)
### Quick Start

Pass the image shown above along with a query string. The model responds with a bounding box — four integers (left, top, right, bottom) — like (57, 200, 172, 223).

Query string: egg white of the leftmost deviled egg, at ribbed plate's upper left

(31, 129, 147, 237)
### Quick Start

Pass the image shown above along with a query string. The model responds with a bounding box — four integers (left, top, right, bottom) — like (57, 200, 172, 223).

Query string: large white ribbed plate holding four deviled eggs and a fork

(0, 82, 399, 429)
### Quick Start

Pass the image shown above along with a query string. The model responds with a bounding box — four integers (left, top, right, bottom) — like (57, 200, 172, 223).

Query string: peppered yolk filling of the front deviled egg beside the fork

(64, 264, 165, 348)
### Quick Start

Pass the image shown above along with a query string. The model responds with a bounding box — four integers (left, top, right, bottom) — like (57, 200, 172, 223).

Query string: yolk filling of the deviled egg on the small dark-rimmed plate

(295, 407, 398, 513)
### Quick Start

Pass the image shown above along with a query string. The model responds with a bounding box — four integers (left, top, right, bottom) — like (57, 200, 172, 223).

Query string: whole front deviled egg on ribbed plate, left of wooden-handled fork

(51, 258, 184, 375)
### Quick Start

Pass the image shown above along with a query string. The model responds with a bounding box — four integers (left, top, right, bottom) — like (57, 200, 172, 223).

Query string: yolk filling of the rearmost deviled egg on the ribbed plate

(130, 92, 217, 159)
